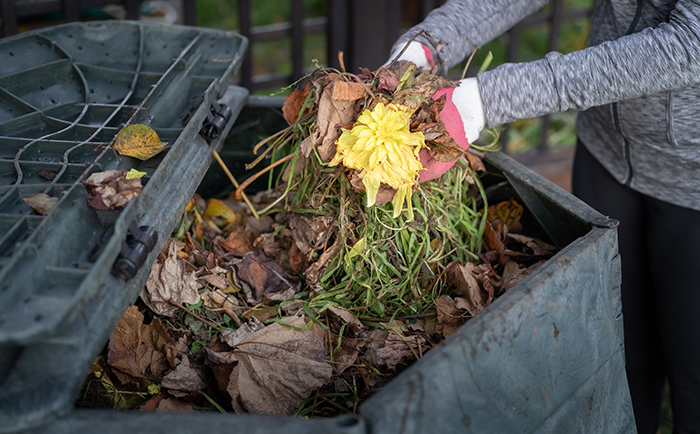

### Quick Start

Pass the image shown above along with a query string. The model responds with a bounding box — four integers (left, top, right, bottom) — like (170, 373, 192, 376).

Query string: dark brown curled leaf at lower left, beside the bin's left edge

(107, 306, 177, 384)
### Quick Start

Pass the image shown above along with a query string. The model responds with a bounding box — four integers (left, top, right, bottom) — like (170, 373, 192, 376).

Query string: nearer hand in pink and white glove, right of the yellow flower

(418, 78, 486, 182)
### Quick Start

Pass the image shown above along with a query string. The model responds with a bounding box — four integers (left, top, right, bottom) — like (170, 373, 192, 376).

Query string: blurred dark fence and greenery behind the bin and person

(0, 0, 596, 190)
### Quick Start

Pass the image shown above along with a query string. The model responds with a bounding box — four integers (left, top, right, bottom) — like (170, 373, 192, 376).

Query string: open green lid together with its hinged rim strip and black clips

(0, 21, 248, 432)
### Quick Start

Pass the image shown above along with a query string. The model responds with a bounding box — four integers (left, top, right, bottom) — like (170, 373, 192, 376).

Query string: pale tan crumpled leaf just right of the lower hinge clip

(140, 239, 201, 316)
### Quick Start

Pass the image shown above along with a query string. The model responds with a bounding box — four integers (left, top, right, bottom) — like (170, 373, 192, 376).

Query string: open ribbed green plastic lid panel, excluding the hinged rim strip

(0, 21, 247, 344)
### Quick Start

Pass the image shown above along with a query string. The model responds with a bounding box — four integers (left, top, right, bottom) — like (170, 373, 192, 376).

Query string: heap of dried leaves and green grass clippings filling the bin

(79, 62, 555, 416)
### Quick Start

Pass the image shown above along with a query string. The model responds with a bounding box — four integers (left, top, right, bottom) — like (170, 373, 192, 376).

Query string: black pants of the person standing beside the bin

(573, 142, 700, 434)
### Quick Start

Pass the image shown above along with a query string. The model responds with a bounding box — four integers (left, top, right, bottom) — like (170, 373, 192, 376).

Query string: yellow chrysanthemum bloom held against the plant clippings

(330, 103, 425, 219)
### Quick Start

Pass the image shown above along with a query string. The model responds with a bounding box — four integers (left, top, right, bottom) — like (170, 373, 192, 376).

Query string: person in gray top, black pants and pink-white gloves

(390, 0, 700, 434)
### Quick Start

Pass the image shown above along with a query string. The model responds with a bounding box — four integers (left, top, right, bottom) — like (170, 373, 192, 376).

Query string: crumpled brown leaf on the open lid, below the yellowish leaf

(85, 170, 143, 210)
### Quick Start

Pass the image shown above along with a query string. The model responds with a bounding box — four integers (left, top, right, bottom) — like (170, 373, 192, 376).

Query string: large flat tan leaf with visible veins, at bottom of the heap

(210, 317, 333, 414)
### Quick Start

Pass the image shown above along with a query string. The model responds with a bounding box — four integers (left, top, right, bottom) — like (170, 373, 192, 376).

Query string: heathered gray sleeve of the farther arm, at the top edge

(396, 0, 548, 73)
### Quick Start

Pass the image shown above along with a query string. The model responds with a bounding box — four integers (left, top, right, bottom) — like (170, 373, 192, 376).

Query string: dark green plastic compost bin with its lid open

(0, 22, 636, 434)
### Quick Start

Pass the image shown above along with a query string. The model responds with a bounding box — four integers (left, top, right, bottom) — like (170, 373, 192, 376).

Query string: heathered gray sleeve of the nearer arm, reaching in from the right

(477, 0, 700, 126)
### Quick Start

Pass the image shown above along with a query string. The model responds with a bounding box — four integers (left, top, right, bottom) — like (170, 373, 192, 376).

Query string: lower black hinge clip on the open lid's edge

(112, 222, 158, 280)
